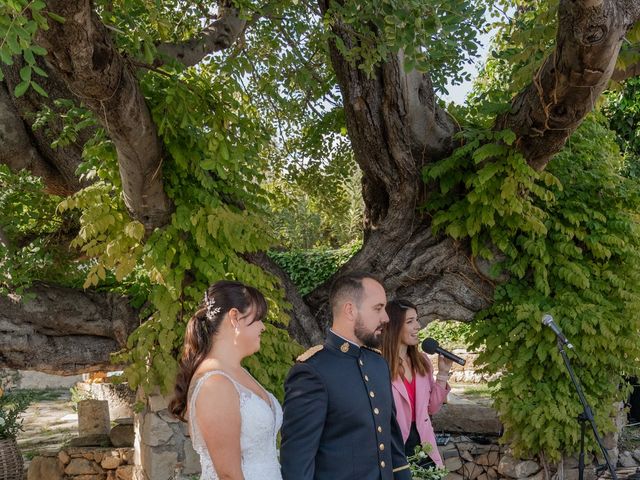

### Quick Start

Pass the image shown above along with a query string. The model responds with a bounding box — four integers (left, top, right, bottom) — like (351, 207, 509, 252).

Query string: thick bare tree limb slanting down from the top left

(38, 0, 172, 231)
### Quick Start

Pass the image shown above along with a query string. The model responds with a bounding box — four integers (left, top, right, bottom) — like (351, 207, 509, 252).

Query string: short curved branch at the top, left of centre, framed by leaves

(158, 7, 247, 67)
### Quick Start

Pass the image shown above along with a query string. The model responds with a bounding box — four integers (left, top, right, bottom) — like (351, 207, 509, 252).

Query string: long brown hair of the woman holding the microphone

(382, 300, 431, 380)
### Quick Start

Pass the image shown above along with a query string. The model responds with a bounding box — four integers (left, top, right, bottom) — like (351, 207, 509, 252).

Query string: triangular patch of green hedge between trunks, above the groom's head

(269, 243, 361, 295)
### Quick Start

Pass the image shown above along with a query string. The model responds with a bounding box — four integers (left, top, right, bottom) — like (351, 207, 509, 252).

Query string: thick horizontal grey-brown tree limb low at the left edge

(0, 285, 139, 375)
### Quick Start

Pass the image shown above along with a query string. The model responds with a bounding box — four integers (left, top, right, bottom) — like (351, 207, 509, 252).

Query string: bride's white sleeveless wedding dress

(189, 370, 282, 480)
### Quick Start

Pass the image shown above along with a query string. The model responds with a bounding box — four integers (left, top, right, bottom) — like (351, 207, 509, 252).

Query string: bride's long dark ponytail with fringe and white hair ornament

(169, 280, 267, 422)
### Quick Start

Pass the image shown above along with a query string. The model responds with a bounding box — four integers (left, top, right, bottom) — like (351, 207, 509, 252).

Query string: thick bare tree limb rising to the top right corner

(496, 0, 639, 170)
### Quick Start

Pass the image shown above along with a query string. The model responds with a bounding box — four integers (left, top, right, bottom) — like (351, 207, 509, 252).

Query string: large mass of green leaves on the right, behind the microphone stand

(425, 116, 640, 459)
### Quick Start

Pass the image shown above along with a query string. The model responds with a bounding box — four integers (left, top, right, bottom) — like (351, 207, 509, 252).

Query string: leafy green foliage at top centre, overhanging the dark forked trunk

(325, 0, 484, 92)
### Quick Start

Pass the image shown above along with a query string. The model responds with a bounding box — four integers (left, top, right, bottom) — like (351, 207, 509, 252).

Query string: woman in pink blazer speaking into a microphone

(382, 300, 452, 467)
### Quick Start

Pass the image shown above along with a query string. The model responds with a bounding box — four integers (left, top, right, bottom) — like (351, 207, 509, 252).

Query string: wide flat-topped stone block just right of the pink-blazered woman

(431, 403, 502, 436)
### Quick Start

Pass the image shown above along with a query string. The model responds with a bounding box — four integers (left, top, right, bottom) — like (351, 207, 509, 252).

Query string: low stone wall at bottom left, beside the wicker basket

(27, 447, 135, 480)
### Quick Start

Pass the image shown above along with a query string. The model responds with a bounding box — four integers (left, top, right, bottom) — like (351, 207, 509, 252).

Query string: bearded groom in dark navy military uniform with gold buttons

(280, 273, 411, 480)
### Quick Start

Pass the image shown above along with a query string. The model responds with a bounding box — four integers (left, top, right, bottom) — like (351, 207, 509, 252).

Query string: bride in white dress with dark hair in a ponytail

(169, 281, 282, 480)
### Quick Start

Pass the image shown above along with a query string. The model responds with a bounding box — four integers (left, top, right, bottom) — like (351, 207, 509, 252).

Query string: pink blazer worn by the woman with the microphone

(391, 355, 451, 466)
